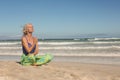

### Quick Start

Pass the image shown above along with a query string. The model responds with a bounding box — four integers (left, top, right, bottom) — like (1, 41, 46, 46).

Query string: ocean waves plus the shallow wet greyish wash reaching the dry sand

(0, 38, 120, 64)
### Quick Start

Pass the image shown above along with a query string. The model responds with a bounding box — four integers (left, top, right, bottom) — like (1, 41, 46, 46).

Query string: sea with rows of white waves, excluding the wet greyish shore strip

(0, 38, 120, 56)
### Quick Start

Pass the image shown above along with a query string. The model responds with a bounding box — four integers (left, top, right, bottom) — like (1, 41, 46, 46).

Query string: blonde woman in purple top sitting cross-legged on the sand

(21, 23, 53, 66)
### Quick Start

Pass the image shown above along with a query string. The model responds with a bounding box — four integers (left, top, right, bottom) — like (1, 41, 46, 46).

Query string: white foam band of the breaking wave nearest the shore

(0, 52, 120, 57)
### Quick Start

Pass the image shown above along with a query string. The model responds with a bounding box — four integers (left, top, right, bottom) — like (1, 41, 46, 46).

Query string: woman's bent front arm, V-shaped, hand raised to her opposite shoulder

(22, 37, 37, 53)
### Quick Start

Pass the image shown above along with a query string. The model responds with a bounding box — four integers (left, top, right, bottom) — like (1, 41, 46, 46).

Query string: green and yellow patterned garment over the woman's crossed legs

(20, 54, 53, 66)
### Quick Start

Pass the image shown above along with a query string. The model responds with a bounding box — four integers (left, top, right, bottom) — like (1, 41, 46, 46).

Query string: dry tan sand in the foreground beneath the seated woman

(0, 61, 120, 80)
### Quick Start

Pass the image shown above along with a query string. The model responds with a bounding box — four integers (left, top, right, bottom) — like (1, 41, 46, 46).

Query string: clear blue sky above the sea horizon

(0, 0, 120, 38)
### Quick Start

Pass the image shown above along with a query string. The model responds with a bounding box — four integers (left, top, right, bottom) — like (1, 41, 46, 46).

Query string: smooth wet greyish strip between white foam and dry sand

(0, 55, 120, 65)
